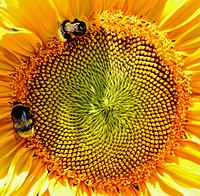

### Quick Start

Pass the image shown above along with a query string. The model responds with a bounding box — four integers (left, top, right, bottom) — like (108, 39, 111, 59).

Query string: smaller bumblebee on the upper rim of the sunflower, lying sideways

(60, 19, 87, 40)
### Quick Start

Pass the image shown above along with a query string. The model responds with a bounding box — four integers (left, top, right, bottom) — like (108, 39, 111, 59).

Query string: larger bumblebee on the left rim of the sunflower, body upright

(11, 103, 34, 140)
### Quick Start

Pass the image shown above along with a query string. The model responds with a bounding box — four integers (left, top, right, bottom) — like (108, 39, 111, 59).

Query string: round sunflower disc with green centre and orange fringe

(12, 11, 189, 186)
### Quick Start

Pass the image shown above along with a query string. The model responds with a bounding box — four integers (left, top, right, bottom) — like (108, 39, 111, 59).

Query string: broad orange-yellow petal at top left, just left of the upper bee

(2, 0, 58, 43)
